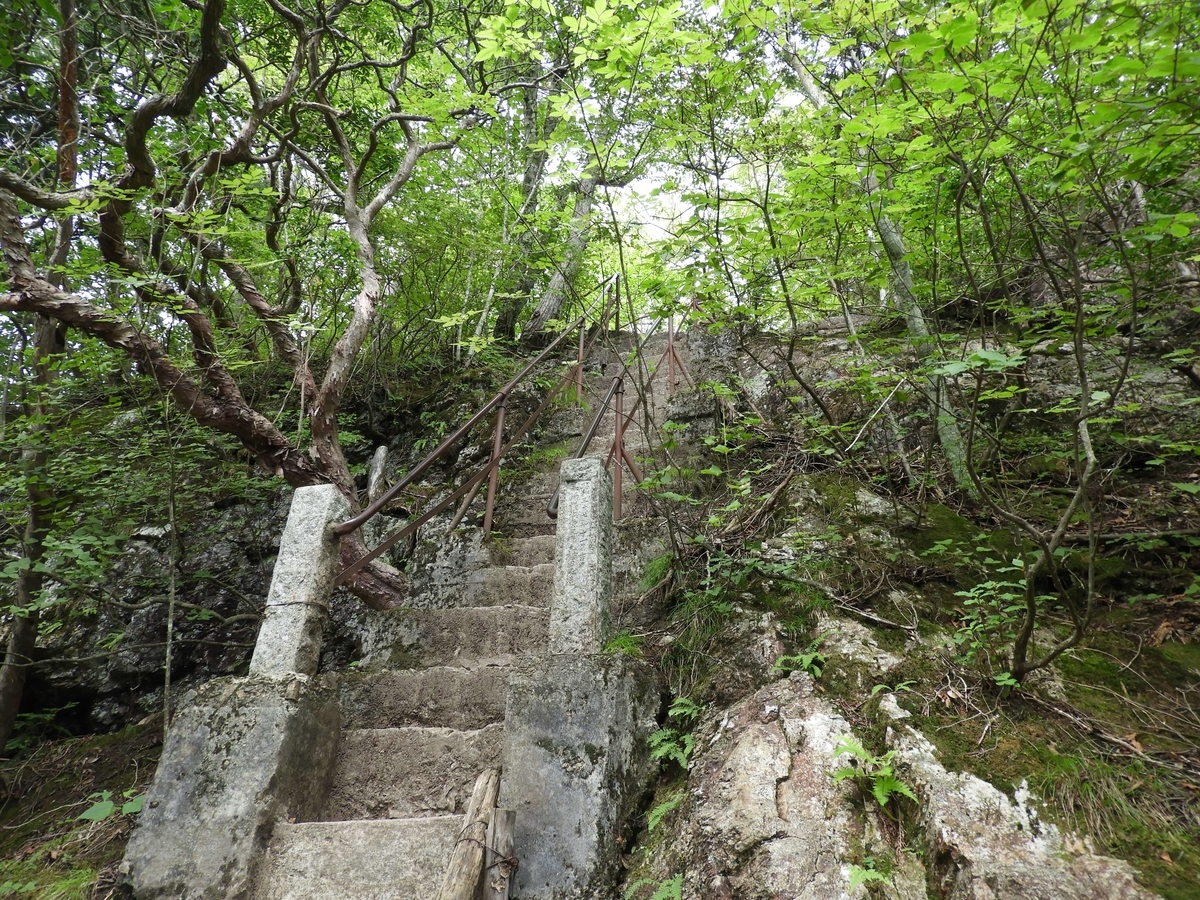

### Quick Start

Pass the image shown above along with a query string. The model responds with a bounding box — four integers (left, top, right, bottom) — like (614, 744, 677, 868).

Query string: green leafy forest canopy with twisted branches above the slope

(0, 0, 1200, 743)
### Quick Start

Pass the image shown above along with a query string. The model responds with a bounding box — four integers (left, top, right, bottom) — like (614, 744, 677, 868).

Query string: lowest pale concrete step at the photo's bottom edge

(254, 816, 462, 900)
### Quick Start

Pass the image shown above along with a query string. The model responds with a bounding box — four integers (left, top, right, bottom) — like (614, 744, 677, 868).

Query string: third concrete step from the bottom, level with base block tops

(341, 666, 511, 728)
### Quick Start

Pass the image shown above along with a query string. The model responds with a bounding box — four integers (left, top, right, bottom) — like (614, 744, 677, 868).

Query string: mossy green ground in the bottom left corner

(0, 722, 162, 900)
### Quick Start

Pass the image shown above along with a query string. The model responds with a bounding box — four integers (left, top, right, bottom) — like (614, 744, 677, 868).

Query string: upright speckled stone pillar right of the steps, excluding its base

(550, 456, 612, 653)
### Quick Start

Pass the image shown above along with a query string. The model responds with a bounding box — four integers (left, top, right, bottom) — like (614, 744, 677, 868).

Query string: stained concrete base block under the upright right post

(499, 656, 659, 900)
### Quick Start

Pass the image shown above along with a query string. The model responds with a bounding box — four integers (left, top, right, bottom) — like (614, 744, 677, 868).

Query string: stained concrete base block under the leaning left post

(122, 676, 341, 900)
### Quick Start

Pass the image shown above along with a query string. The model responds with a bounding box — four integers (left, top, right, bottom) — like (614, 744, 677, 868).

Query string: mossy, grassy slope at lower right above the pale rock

(883, 631, 1200, 900)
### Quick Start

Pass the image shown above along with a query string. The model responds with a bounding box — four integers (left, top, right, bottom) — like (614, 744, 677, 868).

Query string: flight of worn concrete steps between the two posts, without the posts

(256, 528, 554, 900)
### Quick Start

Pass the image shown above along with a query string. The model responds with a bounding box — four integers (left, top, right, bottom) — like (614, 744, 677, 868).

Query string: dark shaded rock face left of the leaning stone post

(23, 490, 292, 731)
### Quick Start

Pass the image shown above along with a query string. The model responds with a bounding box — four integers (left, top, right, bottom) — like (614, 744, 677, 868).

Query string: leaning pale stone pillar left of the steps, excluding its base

(250, 485, 350, 678)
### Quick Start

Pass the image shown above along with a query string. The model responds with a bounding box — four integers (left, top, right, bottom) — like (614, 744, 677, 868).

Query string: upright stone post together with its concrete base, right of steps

(500, 457, 659, 900)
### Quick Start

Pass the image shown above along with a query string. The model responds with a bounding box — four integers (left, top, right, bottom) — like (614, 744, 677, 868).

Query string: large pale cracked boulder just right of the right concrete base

(652, 672, 864, 900)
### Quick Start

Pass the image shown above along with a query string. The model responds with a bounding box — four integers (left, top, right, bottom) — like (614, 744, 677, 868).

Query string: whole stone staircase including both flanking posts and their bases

(122, 328, 696, 900)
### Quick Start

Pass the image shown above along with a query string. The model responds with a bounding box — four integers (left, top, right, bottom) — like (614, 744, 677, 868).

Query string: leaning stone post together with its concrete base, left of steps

(122, 485, 349, 900)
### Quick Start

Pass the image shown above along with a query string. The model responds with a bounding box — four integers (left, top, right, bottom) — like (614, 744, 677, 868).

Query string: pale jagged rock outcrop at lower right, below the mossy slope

(880, 695, 1157, 900)
